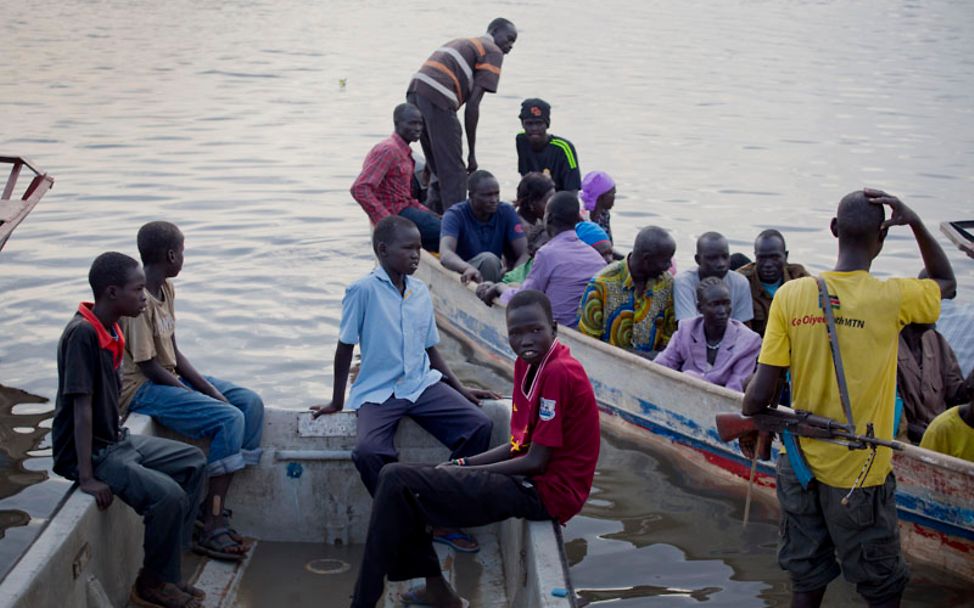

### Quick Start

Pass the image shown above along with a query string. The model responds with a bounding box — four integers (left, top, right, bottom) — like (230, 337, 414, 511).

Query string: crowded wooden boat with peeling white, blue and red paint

(416, 252, 974, 581)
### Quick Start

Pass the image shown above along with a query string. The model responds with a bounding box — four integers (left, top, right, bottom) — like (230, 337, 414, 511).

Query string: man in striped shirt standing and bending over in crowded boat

(406, 18, 517, 213)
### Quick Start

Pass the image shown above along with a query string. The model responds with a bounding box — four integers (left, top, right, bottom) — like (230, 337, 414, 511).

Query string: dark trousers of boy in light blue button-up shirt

(352, 382, 493, 496)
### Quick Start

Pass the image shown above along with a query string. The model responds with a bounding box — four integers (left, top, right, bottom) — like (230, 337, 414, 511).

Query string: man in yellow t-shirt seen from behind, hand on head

(744, 189, 956, 607)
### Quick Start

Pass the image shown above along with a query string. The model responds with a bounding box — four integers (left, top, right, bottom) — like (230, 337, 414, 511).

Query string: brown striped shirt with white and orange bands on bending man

(407, 36, 504, 111)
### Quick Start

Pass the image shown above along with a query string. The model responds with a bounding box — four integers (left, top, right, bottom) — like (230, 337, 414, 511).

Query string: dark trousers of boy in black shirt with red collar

(91, 432, 206, 583)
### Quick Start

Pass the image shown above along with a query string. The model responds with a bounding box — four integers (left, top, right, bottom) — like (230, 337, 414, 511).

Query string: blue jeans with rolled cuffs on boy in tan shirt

(129, 376, 264, 477)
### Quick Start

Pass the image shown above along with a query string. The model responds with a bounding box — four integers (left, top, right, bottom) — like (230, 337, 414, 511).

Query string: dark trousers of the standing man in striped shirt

(406, 93, 467, 213)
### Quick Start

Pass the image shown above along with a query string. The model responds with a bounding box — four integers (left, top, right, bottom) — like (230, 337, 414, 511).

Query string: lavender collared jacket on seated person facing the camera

(655, 316, 761, 391)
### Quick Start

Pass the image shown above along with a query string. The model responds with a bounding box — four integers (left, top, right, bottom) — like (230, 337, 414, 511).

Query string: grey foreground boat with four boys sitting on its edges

(0, 401, 575, 608)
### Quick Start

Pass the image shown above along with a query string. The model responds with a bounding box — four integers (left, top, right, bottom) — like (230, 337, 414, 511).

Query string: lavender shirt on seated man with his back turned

(500, 230, 605, 327)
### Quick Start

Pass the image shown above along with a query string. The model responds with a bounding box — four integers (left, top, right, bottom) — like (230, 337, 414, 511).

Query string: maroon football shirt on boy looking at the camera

(511, 340, 599, 523)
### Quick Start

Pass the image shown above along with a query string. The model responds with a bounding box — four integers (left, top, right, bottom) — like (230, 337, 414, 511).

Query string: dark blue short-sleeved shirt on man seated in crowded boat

(440, 199, 525, 261)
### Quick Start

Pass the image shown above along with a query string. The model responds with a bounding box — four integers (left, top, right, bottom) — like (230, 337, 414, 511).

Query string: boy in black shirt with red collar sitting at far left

(52, 252, 206, 608)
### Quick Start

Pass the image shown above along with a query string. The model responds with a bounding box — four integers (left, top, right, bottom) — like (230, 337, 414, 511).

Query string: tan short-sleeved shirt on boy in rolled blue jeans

(119, 279, 176, 413)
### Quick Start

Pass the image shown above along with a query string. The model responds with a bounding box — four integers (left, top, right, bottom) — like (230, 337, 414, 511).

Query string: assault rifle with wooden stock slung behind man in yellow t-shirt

(717, 407, 903, 460)
